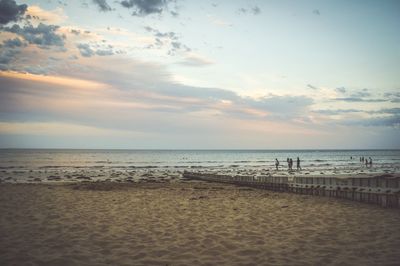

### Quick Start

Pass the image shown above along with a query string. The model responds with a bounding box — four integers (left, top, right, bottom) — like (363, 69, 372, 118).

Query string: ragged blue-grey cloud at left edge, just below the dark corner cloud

(2, 23, 65, 48)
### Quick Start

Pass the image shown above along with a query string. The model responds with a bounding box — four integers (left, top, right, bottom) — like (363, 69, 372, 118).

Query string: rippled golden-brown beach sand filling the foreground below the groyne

(0, 181, 400, 265)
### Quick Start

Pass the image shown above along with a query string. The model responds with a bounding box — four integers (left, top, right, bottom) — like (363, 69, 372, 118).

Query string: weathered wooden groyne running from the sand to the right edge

(183, 172, 400, 208)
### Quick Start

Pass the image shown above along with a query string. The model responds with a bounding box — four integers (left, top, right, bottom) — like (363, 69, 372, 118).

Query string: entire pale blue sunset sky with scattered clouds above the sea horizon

(0, 0, 400, 149)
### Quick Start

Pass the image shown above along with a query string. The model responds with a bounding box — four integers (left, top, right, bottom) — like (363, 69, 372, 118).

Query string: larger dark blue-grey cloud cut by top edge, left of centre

(121, 0, 170, 16)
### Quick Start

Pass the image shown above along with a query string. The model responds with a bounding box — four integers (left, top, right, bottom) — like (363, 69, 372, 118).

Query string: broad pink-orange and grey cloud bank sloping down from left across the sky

(0, 52, 394, 145)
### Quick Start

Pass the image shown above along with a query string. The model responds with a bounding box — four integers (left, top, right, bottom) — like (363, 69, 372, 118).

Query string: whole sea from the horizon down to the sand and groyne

(0, 149, 400, 182)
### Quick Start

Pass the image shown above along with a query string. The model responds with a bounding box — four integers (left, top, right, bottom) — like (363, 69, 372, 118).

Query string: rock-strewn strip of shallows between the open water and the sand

(0, 167, 400, 183)
